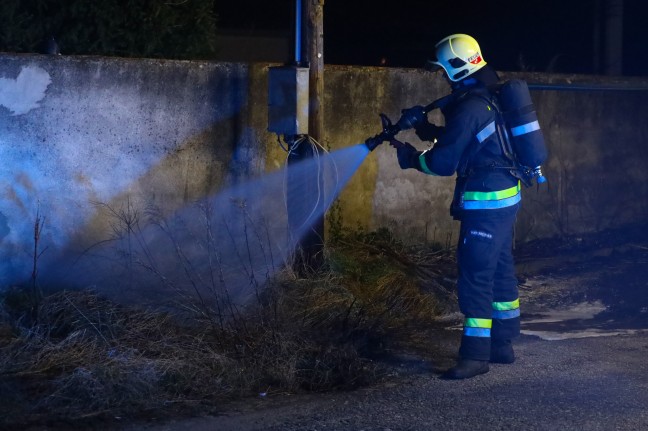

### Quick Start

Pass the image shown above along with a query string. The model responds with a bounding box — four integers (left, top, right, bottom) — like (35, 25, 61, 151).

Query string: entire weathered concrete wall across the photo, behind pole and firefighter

(0, 55, 648, 285)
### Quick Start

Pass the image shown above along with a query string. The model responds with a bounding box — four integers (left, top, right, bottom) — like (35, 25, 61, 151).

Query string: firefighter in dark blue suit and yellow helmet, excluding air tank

(395, 34, 521, 379)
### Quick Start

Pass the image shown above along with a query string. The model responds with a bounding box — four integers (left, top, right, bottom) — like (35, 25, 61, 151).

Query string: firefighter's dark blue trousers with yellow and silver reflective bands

(457, 204, 520, 361)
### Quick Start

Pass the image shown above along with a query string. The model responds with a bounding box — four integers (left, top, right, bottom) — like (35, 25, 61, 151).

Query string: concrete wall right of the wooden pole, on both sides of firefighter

(325, 67, 648, 243)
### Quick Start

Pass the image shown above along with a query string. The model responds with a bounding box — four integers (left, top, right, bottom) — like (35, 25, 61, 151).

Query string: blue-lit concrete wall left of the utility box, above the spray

(0, 55, 265, 285)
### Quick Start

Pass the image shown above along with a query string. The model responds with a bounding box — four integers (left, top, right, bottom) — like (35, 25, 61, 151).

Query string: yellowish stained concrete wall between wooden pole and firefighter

(325, 67, 457, 242)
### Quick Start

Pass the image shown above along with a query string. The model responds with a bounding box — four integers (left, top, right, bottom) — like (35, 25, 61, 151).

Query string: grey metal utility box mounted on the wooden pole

(268, 66, 309, 135)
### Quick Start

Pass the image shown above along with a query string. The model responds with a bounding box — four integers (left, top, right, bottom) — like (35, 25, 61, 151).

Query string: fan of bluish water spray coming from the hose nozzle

(45, 144, 369, 303)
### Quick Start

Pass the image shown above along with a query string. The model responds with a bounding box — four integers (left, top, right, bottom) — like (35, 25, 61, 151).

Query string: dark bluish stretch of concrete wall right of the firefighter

(518, 75, 648, 240)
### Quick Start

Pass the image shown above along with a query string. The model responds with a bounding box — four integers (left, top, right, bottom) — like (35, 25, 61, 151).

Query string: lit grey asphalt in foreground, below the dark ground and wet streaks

(132, 331, 648, 431)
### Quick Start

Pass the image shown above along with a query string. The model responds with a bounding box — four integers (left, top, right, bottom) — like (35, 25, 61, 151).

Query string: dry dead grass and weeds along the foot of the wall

(0, 231, 454, 427)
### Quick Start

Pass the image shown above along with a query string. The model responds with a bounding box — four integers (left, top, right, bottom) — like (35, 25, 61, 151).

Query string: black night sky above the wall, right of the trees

(218, 0, 648, 76)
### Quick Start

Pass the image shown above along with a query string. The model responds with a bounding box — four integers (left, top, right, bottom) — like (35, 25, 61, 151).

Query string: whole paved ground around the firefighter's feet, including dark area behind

(104, 227, 648, 431)
